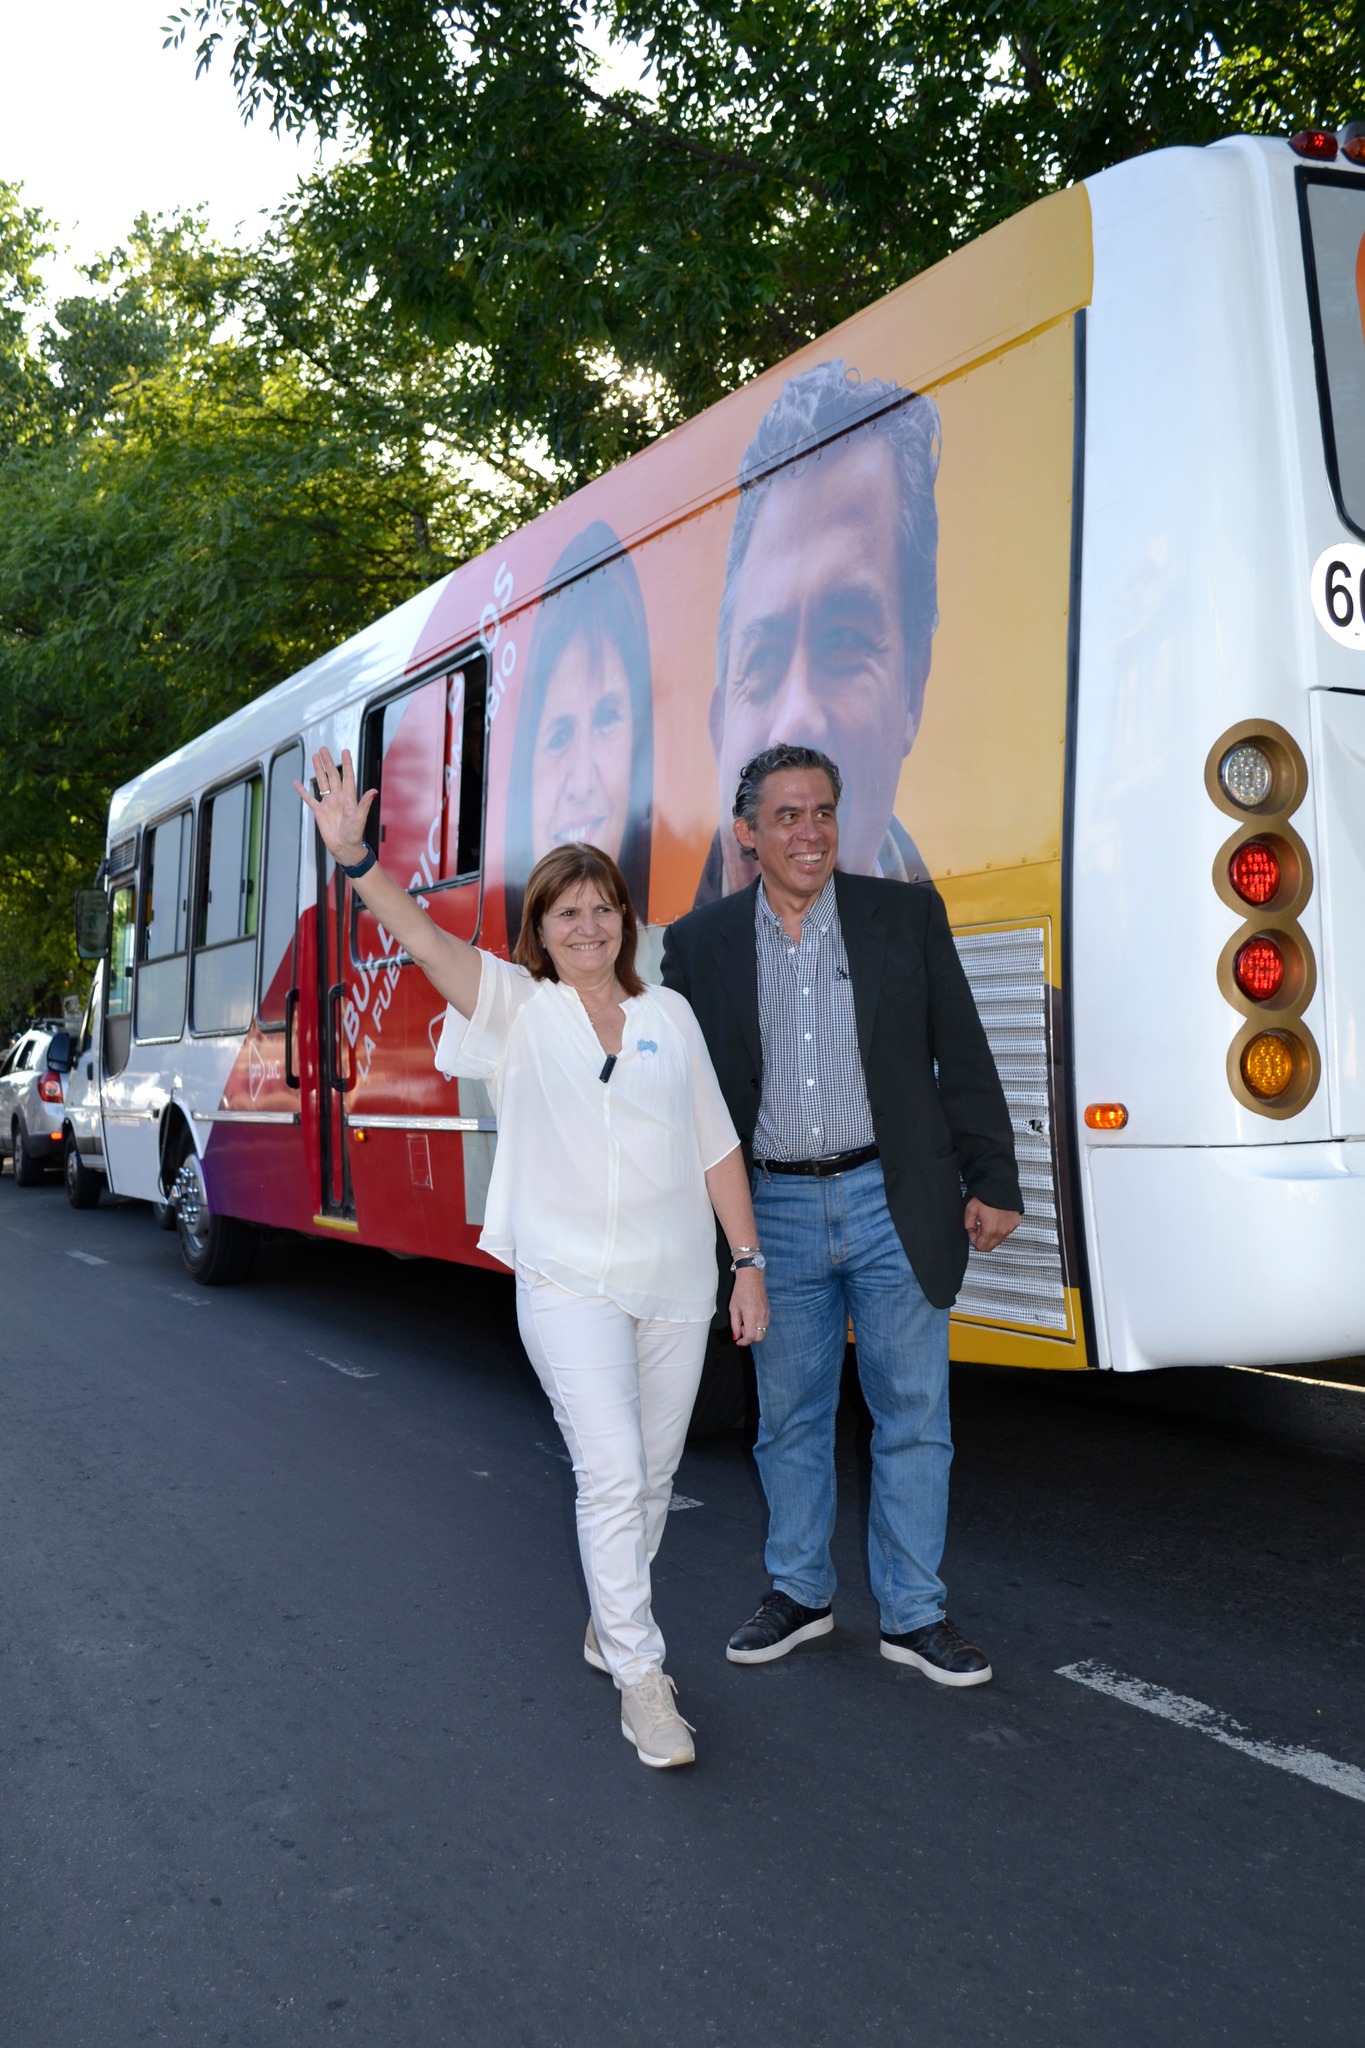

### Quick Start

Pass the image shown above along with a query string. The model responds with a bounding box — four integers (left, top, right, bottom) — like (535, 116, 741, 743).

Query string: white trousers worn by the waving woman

(516, 1272, 710, 1686)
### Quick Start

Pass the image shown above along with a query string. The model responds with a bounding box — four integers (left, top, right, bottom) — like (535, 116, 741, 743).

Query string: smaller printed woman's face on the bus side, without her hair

(530, 635, 634, 860)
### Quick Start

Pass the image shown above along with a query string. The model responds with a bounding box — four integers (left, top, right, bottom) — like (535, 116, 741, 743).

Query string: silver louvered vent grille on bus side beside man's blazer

(956, 926, 1070, 1331)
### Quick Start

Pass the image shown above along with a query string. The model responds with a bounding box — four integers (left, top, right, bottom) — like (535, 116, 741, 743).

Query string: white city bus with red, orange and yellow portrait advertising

(65, 131, 1365, 1370)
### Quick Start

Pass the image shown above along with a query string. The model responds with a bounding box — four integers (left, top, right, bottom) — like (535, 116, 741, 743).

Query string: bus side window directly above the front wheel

(192, 774, 262, 1032)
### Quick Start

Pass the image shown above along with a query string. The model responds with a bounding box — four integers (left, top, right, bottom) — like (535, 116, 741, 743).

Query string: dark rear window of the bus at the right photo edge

(1302, 178, 1365, 535)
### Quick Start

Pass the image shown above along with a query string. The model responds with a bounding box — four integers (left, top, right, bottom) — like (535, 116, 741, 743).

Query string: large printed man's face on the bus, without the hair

(714, 444, 917, 889)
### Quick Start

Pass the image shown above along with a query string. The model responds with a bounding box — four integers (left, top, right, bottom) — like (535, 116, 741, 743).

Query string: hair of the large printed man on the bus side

(716, 360, 939, 717)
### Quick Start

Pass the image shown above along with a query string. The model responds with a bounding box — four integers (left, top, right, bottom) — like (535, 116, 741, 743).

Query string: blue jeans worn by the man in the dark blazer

(753, 1159, 954, 1634)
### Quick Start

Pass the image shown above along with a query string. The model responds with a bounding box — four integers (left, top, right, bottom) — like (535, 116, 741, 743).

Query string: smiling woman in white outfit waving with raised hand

(295, 748, 767, 1767)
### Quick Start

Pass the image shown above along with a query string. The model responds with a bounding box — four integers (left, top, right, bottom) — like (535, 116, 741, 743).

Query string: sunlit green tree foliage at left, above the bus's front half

(0, 186, 553, 1020)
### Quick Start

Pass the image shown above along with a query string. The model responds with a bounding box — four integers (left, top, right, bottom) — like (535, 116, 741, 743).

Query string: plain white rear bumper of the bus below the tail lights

(1087, 1141, 1365, 1372)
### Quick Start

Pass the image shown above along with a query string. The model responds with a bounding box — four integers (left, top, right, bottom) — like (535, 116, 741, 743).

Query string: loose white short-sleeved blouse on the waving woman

(436, 952, 739, 1323)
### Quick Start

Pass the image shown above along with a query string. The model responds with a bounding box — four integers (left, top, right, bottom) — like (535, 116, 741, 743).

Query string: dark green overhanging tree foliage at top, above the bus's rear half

(178, 0, 1365, 481)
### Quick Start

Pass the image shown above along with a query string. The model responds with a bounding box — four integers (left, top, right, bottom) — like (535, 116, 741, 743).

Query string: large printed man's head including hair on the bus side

(704, 362, 937, 895)
